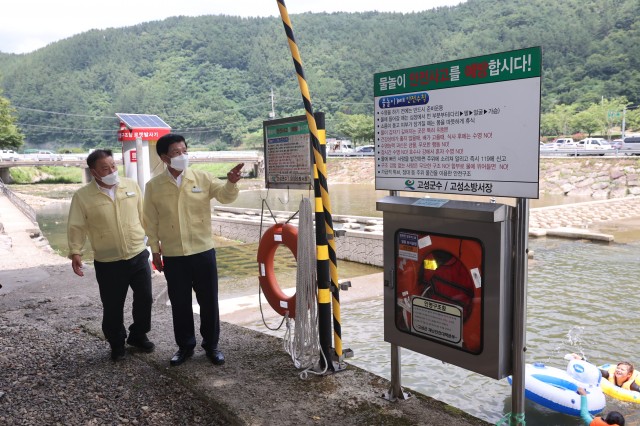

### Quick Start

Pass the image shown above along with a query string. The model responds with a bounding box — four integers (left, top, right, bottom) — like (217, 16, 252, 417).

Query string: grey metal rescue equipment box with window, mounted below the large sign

(377, 196, 513, 379)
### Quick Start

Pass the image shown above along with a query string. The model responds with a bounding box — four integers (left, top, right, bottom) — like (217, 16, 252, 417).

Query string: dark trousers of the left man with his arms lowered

(93, 250, 153, 346)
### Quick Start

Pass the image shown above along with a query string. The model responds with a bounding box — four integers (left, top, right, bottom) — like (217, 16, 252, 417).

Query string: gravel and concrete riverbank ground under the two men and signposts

(0, 196, 488, 426)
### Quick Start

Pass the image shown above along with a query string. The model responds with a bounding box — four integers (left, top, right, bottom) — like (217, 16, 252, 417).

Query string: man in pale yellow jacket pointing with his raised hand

(144, 133, 243, 366)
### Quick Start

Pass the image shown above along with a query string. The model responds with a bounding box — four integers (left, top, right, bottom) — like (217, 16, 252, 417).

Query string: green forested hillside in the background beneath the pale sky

(0, 0, 640, 147)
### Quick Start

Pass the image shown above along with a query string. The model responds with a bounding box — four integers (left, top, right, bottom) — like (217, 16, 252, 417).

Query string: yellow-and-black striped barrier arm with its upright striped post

(277, 0, 342, 371)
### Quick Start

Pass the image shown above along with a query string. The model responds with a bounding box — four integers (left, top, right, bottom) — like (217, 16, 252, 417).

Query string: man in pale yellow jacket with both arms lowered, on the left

(67, 149, 154, 361)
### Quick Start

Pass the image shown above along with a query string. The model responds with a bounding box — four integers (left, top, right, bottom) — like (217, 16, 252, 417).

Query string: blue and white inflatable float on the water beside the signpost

(508, 360, 605, 416)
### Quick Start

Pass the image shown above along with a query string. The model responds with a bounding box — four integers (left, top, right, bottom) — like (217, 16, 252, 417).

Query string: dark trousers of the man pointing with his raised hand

(163, 249, 220, 350)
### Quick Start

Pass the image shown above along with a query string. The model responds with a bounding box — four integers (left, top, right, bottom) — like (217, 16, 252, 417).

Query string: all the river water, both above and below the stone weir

(27, 185, 640, 425)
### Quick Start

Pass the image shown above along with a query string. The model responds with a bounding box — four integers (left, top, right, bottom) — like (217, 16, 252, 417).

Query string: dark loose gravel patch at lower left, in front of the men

(0, 316, 228, 425)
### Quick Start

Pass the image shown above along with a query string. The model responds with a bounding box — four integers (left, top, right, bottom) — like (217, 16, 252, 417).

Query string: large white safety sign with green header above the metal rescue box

(374, 47, 542, 198)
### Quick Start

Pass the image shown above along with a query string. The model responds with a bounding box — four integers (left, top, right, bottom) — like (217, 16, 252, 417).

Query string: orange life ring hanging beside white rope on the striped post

(258, 223, 298, 318)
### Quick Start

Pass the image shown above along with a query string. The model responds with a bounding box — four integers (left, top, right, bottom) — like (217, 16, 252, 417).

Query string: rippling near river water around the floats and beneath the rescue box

(241, 238, 640, 426)
